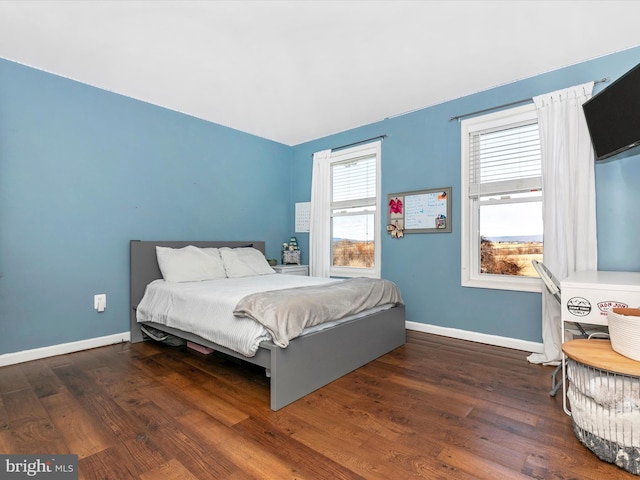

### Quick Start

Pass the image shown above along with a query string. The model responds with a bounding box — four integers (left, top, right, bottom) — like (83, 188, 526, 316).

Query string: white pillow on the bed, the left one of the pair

(156, 245, 227, 282)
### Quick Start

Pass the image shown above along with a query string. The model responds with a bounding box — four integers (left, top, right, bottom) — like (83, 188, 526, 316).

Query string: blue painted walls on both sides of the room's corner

(0, 48, 640, 354)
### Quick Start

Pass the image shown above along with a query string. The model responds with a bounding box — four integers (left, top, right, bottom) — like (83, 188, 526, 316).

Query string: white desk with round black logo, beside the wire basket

(560, 271, 640, 415)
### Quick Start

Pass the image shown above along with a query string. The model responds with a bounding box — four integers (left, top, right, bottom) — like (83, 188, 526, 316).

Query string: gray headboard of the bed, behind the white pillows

(129, 240, 264, 343)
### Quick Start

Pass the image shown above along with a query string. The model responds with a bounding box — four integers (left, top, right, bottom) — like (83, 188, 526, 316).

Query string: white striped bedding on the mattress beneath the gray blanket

(136, 274, 360, 357)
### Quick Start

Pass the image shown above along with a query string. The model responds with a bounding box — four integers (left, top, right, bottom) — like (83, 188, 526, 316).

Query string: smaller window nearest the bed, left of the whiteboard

(330, 142, 380, 277)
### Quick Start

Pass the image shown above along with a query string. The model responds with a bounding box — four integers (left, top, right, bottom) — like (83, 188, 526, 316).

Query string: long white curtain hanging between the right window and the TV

(528, 82, 598, 365)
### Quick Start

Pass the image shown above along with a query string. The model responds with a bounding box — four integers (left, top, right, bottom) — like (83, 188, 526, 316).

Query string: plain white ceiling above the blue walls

(0, 0, 640, 145)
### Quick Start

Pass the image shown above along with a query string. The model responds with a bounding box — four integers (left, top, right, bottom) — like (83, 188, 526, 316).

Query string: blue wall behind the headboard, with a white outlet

(0, 59, 291, 354)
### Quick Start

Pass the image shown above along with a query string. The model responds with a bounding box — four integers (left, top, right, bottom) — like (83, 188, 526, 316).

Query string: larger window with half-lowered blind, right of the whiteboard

(461, 105, 543, 291)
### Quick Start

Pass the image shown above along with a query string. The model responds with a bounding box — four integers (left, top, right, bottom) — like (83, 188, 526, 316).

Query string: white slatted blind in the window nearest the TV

(469, 122, 542, 198)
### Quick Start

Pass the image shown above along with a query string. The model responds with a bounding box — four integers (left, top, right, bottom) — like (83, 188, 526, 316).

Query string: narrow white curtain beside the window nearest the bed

(309, 150, 331, 277)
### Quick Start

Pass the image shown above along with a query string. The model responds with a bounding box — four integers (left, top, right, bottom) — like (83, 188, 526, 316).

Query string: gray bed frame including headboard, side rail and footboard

(130, 240, 406, 410)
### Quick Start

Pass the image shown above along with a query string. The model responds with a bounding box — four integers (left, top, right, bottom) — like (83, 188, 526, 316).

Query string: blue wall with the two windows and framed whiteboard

(292, 48, 640, 342)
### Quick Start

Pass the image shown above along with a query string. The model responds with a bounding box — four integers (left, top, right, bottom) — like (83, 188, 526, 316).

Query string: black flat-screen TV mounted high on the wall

(582, 64, 640, 160)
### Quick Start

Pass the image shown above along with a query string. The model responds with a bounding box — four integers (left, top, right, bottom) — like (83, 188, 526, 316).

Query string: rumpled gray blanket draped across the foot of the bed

(233, 278, 402, 347)
